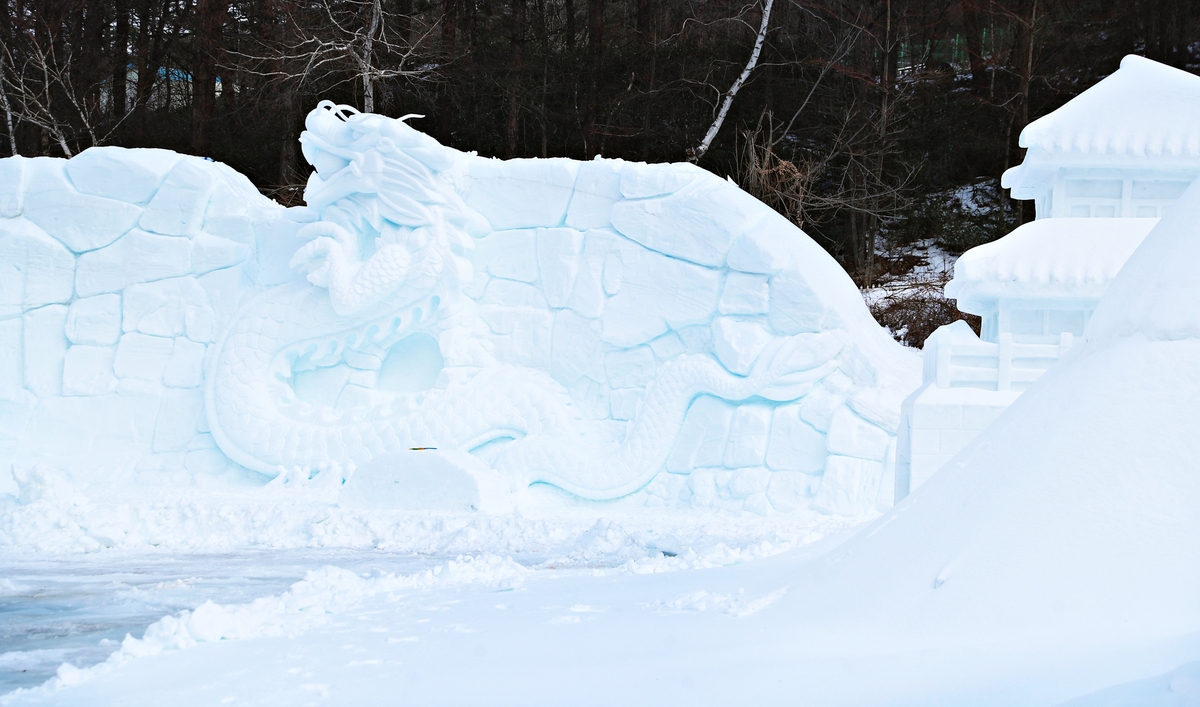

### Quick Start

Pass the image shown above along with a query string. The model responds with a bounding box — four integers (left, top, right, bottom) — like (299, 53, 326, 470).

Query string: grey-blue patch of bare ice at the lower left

(0, 549, 445, 694)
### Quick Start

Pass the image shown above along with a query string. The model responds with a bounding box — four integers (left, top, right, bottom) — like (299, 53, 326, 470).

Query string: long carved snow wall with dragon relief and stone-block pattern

(0, 102, 920, 515)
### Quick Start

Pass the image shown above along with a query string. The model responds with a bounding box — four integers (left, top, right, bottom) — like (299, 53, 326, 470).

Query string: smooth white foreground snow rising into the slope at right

(7, 164, 1200, 706)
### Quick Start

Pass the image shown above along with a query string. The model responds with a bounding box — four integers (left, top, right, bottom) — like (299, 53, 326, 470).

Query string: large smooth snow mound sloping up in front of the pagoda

(758, 175, 1200, 700)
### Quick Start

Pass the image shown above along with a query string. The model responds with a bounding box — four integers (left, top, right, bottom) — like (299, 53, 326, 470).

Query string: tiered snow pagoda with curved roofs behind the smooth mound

(895, 56, 1200, 501)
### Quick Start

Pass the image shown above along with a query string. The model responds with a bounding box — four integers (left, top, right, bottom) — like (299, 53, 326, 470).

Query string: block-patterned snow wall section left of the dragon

(0, 148, 305, 486)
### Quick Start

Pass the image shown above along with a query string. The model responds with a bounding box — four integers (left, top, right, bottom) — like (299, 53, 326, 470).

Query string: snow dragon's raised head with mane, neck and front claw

(293, 101, 491, 311)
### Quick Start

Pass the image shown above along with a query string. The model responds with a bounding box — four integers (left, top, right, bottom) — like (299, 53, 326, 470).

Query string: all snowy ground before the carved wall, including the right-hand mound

(11, 186, 1200, 707)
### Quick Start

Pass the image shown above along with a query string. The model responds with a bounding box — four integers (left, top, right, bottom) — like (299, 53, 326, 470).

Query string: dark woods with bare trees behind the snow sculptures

(0, 0, 1200, 286)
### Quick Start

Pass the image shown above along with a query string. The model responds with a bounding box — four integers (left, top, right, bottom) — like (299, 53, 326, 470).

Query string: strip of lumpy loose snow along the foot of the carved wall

(0, 466, 859, 568)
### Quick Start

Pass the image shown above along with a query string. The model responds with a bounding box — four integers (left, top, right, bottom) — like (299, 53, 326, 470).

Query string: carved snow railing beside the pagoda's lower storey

(924, 322, 1075, 390)
